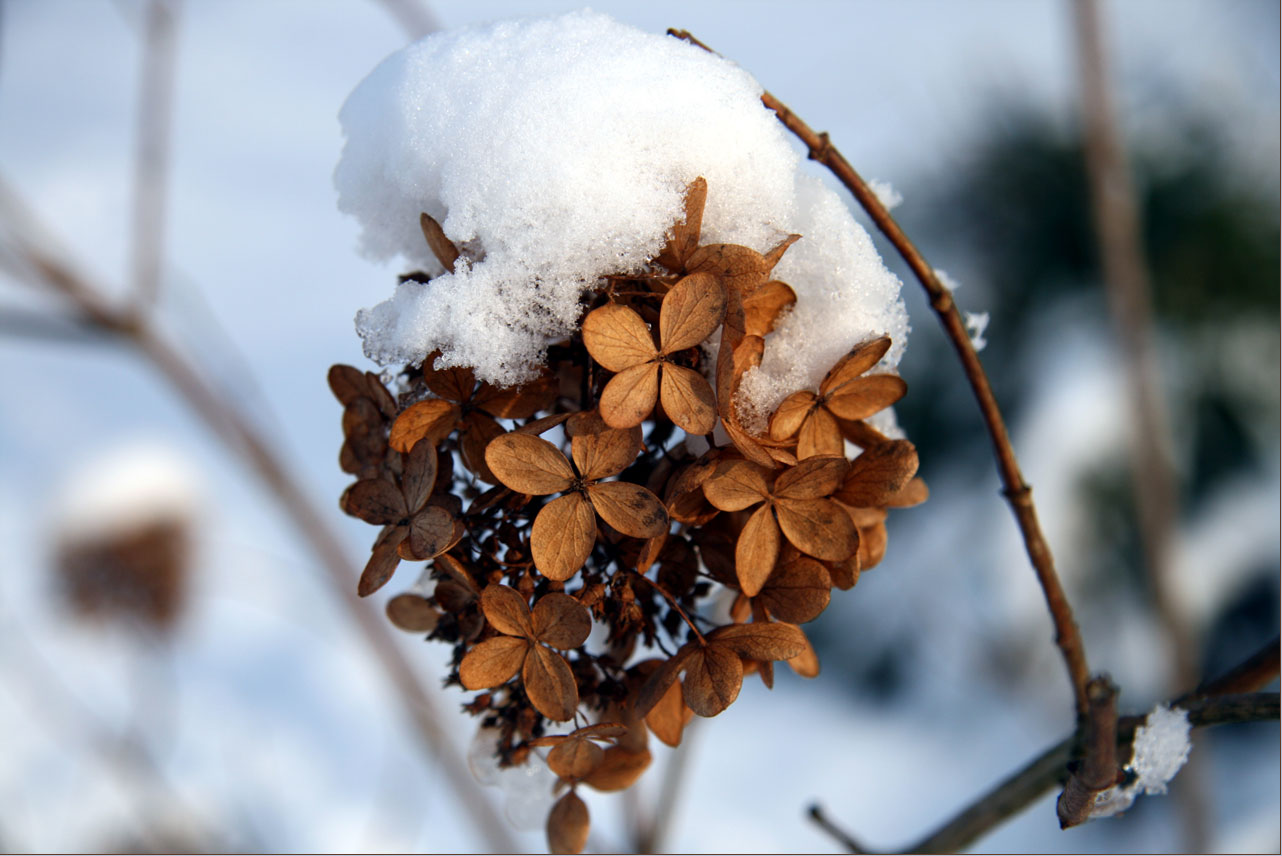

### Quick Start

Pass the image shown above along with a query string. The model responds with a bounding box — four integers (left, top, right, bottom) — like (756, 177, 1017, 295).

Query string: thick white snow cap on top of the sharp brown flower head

(335, 12, 908, 410)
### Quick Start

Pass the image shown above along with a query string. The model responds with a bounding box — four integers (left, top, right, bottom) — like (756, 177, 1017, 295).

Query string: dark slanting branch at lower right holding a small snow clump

(812, 638, 1278, 853)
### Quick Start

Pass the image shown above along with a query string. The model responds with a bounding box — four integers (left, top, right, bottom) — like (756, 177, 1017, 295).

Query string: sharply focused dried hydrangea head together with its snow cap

(329, 13, 926, 852)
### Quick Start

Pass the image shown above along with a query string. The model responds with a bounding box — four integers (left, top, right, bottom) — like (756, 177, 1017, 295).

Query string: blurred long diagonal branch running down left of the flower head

(0, 182, 515, 852)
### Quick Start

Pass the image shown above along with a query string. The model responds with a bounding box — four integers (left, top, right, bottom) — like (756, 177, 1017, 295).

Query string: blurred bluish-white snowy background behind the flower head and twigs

(0, 0, 1279, 852)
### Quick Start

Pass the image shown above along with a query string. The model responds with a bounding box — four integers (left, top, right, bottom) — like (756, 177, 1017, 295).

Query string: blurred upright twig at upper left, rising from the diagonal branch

(132, 0, 178, 313)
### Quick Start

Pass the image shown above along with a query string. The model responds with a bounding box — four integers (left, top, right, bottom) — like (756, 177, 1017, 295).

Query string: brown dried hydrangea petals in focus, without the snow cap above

(329, 178, 926, 852)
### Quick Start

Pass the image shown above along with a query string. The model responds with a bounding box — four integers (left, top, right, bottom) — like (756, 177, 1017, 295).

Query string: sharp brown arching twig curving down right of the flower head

(668, 29, 1090, 720)
